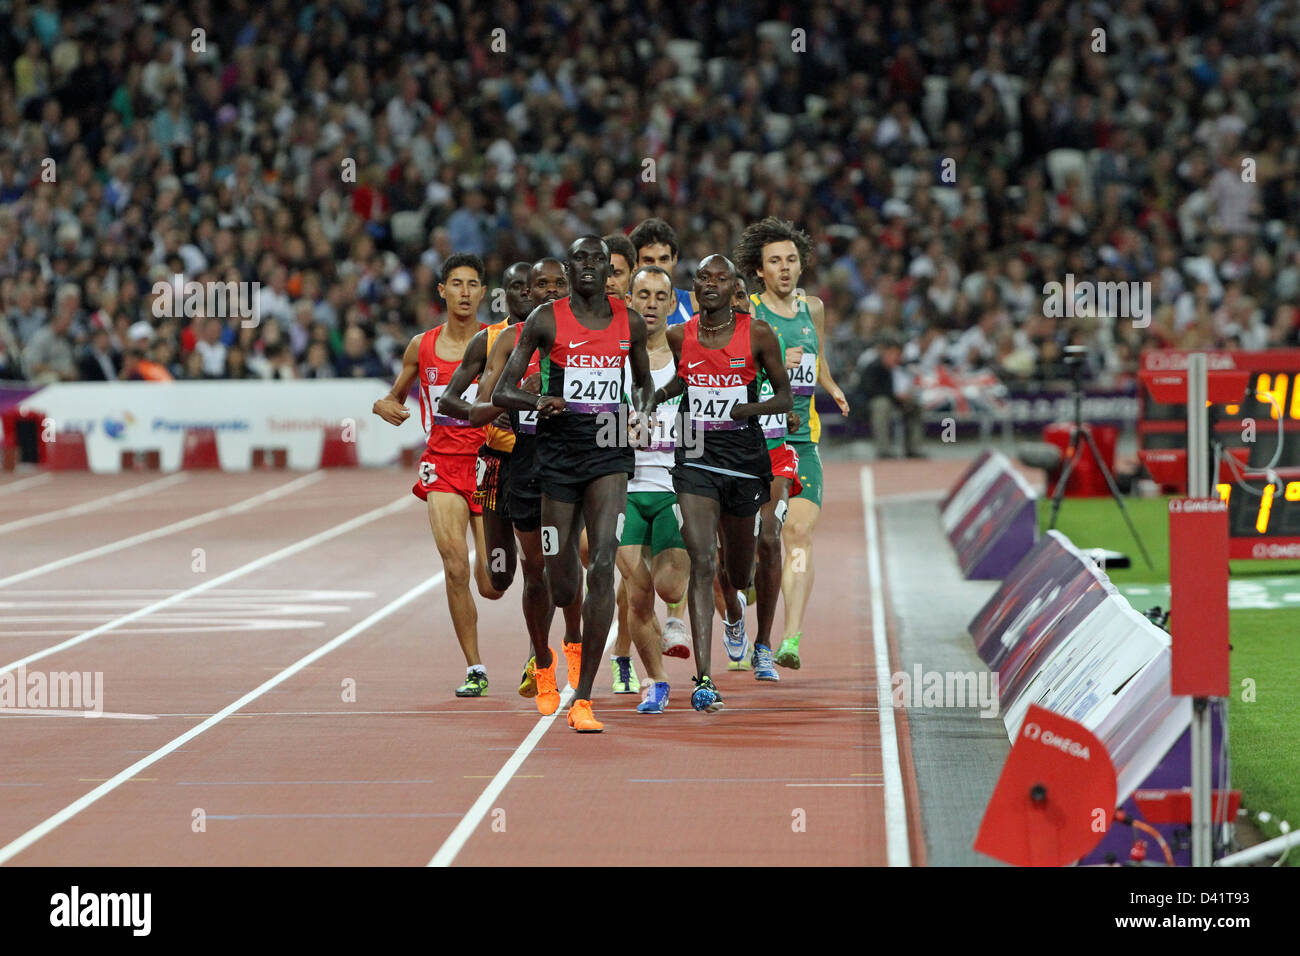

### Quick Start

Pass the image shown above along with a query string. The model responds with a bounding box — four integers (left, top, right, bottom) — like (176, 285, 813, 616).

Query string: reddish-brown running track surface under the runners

(0, 462, 963, 865)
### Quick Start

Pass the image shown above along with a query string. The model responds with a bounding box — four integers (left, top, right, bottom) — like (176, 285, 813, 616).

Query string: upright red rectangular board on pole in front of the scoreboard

(1169, 498, 1229, 697)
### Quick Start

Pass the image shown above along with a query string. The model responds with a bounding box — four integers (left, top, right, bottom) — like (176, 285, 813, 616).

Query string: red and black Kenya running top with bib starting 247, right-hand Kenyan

(676, 312, 771, 476)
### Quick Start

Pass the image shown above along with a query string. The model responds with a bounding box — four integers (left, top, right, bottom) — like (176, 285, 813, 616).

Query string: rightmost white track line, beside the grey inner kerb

(862, 466, 911, 866)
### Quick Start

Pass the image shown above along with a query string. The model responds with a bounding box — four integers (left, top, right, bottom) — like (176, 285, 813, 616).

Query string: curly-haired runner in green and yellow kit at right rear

(736, 216, 849, 670)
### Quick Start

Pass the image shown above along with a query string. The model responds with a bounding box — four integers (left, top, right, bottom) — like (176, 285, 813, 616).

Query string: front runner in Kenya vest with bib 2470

(491, 235, 654, 734)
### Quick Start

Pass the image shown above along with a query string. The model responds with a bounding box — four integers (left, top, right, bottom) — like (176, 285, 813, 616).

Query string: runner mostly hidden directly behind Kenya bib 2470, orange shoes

(469, 259, 582, 715)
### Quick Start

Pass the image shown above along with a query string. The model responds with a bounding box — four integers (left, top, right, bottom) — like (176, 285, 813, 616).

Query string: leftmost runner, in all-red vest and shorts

(373, 252, 502, 697)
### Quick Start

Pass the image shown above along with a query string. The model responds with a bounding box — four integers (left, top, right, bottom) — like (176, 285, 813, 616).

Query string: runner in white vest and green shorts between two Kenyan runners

(615, 265, 690, 714)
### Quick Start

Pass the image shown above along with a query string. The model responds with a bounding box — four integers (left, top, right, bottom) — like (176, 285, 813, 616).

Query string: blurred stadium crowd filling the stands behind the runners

(0, 0, 1300, 421)
